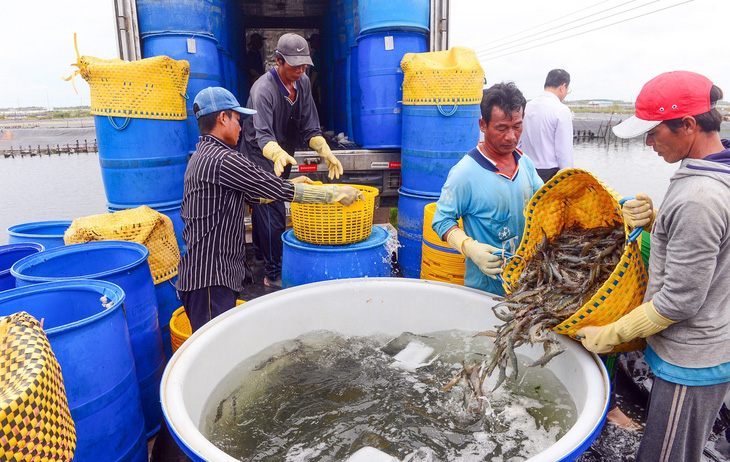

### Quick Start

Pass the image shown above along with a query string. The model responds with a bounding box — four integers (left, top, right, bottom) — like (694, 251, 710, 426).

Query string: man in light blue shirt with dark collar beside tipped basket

(431, 82, 543, 295)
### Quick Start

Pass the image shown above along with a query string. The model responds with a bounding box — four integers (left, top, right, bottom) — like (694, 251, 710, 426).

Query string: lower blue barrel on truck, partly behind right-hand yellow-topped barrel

(357, 32, 428, 149)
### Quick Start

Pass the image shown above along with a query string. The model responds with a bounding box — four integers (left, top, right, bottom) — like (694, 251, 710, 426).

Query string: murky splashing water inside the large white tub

(201, 331, 577, 462)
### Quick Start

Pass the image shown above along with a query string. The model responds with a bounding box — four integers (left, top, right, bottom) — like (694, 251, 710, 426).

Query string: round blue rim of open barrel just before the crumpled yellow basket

(10, 241, 150, 283)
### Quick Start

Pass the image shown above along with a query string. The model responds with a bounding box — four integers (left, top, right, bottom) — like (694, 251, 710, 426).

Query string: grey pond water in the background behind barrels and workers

(0, 139, 678, 245)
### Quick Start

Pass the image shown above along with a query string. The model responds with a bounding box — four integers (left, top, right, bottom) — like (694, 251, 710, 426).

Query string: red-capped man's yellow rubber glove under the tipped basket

(576, 300, 676, 354)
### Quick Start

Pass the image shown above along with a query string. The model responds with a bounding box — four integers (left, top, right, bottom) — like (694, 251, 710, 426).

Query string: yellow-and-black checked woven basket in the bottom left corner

(0, 312, 76, 462)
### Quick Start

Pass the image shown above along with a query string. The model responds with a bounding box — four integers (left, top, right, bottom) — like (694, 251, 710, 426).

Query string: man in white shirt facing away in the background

(518, 69, 573, 183)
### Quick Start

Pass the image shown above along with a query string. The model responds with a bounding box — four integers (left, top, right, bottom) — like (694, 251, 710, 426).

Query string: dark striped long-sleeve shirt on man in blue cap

(176, 135, 294, 291)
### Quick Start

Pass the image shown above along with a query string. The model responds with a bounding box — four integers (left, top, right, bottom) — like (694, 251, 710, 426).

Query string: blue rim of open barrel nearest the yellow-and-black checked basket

(0, 279, 125, 338)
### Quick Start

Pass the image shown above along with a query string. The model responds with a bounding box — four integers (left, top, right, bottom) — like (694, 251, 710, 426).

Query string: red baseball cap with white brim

(613, 71, 712, 138)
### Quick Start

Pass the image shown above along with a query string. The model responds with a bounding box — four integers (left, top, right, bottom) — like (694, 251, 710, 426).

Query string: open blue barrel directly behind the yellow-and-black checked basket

(0, 280, 147, 462)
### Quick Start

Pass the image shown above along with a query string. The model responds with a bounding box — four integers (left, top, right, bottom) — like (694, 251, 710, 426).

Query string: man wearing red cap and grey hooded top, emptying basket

(578, 71, 730, 462)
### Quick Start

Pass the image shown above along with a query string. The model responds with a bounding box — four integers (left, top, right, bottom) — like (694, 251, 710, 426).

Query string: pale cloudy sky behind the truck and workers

(0, 0, 730, 107)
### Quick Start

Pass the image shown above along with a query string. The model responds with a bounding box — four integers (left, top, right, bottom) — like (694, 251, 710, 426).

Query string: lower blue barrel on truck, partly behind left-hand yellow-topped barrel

(142, 33, 223, 152)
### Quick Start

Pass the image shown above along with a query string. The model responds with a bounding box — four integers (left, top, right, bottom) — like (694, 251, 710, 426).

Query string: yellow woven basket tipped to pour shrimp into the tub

(502, 169, 648, 353)
